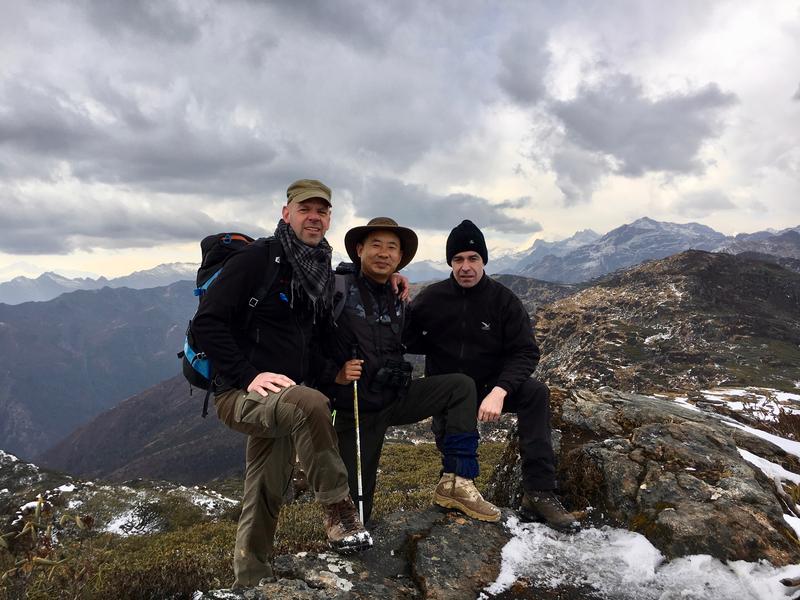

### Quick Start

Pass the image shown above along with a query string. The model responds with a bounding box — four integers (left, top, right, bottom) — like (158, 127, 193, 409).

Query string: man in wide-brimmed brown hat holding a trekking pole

(317, 217, 500, 523)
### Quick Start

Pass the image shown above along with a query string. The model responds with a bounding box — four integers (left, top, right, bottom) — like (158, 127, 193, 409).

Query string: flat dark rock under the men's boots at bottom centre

(196, 508, 511, 600)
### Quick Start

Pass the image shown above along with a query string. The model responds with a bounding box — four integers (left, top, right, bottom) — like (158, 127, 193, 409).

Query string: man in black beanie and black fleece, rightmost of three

(405, 220, 580, 531)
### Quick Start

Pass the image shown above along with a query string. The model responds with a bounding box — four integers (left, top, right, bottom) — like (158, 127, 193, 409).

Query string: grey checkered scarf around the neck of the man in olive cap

(275, 220, 333, 315)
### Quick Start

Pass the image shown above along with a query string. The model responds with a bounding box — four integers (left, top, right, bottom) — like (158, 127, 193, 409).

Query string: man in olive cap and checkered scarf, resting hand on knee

(192, 179, 372, 587)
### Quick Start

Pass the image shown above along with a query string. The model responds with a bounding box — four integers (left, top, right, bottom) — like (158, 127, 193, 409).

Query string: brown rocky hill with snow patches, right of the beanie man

(536, 251, 800, 391)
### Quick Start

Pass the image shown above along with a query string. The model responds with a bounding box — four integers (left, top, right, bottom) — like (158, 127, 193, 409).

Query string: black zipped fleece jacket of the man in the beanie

(404, 273, 540, 398)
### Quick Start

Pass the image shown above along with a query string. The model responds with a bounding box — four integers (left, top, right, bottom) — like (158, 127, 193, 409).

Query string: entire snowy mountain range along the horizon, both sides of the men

(0, 217, 800, 304)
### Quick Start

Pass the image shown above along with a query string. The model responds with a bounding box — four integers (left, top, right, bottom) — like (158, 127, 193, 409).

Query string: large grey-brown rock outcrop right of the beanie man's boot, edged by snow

(489, 388, 800, 565)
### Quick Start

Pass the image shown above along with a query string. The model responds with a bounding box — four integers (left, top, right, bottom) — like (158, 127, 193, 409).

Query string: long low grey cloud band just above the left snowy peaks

(0, 195, 270, 254)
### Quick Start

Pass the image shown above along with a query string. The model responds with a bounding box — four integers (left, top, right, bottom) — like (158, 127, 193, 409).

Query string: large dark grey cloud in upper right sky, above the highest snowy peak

(551, 74, 737, 177)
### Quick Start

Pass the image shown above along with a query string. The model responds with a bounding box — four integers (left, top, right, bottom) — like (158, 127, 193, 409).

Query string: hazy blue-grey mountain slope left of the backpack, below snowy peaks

(0, 281, 197, 457)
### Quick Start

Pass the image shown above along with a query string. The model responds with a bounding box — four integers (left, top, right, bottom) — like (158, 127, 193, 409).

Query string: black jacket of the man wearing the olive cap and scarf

(192, 244, 314, 391)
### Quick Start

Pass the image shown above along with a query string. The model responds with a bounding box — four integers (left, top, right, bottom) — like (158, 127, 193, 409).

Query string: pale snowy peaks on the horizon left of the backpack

(0, 263, 198, 304)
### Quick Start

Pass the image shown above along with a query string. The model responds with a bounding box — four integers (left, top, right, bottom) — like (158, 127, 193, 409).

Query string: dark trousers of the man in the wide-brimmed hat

(334, 374, 478, 523)
